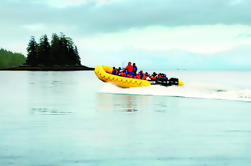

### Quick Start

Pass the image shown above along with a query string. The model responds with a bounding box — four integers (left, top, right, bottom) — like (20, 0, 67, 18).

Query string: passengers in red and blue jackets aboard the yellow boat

(112, 62, 168, 81)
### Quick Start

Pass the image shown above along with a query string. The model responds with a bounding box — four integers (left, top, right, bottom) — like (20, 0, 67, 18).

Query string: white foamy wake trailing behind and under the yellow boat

(100, 83, 251, 102)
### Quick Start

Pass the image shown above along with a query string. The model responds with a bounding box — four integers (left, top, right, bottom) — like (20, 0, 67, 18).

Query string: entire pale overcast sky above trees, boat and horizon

(0, 0, 251, 69)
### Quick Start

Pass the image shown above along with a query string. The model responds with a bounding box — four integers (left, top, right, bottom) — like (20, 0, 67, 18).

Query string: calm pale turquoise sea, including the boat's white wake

(0, 71, 251, 166)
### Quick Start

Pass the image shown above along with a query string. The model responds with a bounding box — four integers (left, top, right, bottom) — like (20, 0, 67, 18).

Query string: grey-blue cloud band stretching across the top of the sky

(0, 0, 251, 34)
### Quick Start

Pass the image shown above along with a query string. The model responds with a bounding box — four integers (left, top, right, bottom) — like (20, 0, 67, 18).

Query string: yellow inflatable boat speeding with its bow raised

(95, 66, 184, 88)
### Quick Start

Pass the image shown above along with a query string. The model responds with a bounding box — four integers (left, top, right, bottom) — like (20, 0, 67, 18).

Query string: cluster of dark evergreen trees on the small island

(26, 33, 81, 66)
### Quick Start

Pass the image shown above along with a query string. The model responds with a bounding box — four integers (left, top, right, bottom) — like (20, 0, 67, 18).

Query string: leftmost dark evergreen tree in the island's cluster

(26, 36, 38, 66)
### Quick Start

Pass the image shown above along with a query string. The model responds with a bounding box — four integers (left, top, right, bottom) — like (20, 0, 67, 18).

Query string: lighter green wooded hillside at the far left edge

(0, 48, 26, 68)
